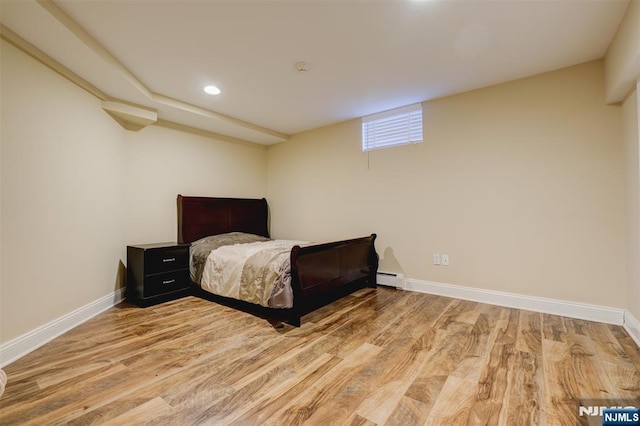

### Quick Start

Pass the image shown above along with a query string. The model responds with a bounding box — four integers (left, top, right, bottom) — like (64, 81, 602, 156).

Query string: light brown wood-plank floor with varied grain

(0, 288, 640, 425)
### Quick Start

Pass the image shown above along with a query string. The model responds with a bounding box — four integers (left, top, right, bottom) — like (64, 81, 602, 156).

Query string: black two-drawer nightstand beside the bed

(127, 243, 191, 307)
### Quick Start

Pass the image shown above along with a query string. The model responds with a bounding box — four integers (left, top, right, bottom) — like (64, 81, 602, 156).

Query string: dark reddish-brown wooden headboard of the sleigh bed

(178, 195, 269, 243)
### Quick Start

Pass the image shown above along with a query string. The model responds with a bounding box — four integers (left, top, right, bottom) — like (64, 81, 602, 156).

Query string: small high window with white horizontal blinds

(362, 104, 422, 151)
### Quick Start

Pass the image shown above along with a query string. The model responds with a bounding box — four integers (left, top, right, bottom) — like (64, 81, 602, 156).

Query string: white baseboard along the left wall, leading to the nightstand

(0, 289, 124, 368)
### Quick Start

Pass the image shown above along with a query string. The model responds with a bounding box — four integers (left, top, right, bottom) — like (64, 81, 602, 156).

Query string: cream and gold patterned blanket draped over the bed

(200, 240, 305, 308)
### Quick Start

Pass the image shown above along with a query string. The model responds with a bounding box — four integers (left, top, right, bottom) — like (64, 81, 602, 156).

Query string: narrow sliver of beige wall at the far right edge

(622, 84, 640, 319)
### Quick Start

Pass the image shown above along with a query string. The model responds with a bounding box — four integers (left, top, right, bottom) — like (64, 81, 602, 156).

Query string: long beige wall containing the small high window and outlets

(268, 62, 627, 307)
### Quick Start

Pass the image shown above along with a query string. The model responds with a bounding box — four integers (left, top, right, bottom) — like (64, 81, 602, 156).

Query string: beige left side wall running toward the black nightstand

(0, 41, 125, 342)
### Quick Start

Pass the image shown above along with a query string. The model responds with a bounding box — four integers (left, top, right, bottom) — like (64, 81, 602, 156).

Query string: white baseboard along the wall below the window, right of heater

(405, 279, 624, 326)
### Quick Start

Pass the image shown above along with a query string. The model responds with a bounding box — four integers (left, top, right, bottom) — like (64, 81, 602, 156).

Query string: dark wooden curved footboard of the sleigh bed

(290, 234, 378, 326)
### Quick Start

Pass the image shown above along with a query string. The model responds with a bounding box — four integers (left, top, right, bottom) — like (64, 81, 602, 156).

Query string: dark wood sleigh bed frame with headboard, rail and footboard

(177, 195, 378, 326)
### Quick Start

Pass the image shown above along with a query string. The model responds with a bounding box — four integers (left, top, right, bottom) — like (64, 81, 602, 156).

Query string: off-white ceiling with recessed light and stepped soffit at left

(0, 0, 628, 145)
